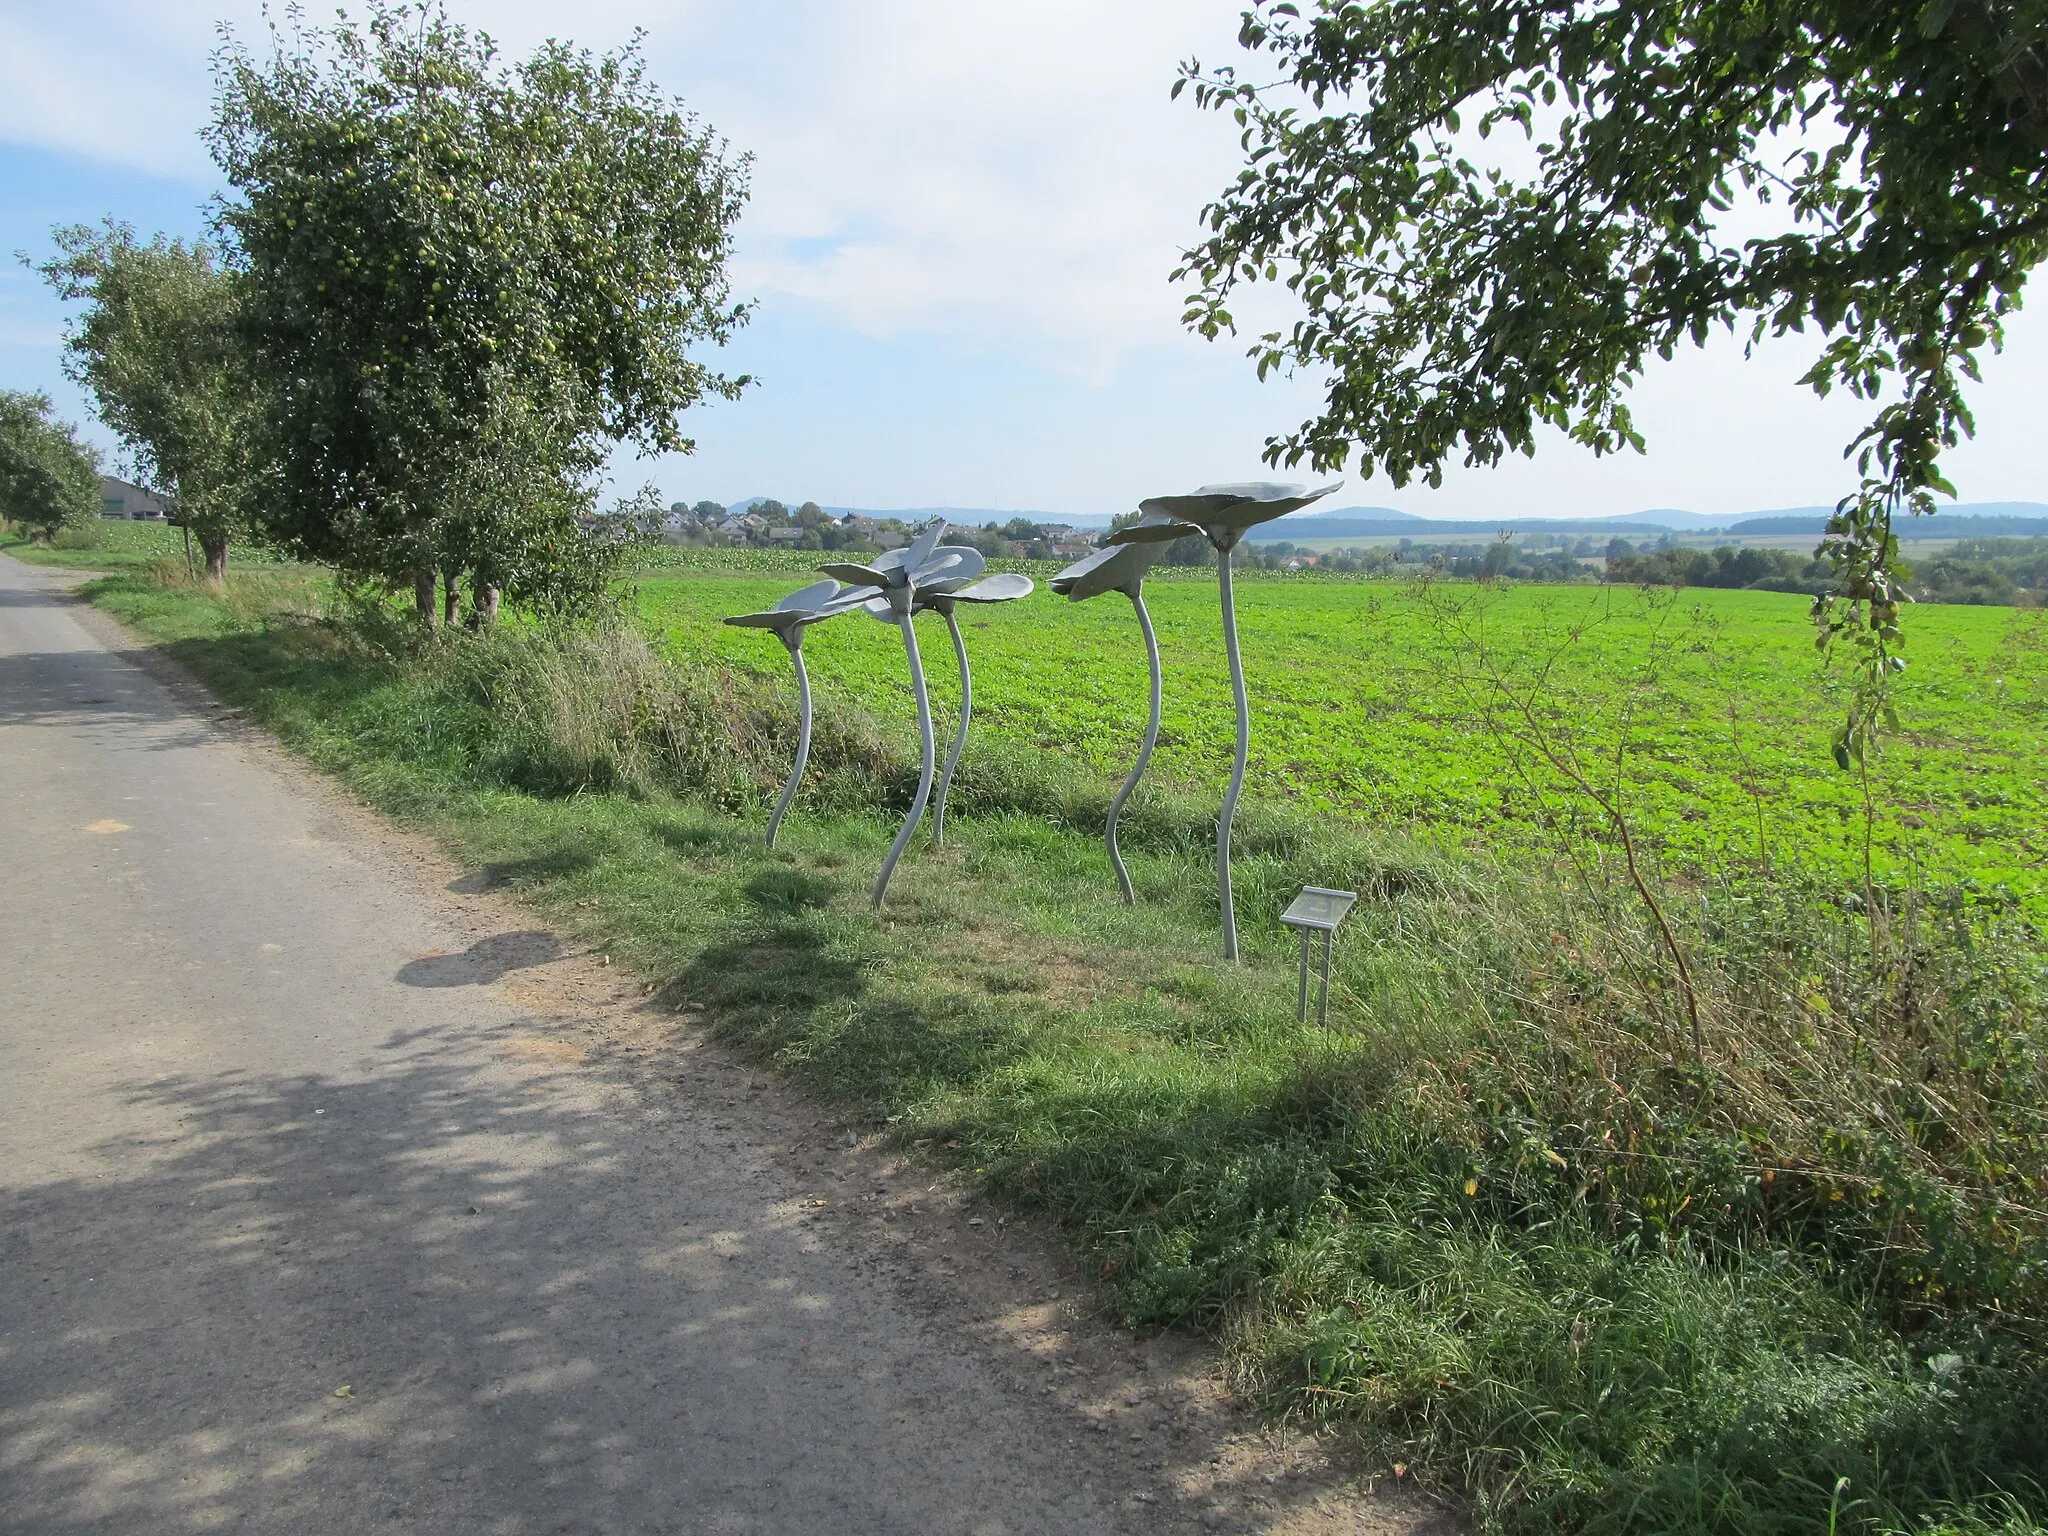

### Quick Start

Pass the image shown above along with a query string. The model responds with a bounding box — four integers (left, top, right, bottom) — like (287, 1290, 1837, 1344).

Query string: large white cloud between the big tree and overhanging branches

(688, 0, 1235, 377)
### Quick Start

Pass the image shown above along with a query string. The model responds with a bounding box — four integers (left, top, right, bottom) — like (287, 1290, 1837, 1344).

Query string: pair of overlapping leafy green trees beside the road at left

(24, 0, 748, 623)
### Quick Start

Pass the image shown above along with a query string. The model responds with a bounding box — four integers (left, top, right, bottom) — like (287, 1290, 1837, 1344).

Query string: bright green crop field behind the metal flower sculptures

(637, 553, 2048, 909)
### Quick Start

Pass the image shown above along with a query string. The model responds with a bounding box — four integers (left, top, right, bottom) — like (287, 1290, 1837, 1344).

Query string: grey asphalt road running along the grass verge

(0, 557, 1146, 1536)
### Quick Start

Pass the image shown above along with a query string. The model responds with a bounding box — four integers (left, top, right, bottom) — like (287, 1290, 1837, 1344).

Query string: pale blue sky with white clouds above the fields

(0, 0, 2048, 518)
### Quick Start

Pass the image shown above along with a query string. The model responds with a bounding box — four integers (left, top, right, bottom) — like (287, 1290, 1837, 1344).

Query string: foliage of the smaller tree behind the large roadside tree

(37, 219, 262, 580)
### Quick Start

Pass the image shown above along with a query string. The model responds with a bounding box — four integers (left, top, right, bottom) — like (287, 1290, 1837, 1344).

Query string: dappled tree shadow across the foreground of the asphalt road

(0, 1030, 1106, 1536)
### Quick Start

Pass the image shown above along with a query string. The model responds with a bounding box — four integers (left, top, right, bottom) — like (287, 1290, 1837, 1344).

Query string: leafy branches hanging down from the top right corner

(1176, 10, 2048, 766)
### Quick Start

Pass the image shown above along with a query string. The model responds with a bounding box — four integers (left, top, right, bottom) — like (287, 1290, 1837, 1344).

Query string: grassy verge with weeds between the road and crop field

(64, 575, 2048, 1534)
